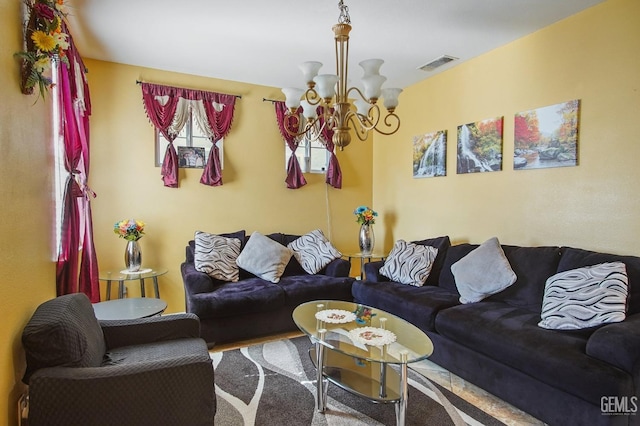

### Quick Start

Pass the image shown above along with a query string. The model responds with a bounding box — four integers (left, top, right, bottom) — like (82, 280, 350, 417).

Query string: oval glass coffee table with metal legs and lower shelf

(293, 300, 433, 426)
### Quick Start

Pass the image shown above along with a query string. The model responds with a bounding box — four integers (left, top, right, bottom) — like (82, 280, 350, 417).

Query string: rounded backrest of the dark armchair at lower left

(22, 293, 106, 383)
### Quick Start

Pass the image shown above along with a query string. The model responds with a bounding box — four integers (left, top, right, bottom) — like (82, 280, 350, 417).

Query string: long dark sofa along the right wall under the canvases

(353, 237, 640, 426)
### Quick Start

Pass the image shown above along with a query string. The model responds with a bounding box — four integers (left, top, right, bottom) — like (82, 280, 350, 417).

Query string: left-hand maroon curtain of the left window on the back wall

(142, 83, 179, 188)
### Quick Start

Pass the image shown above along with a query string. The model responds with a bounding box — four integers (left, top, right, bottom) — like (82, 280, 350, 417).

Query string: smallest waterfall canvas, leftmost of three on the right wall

(413, 130, 447, 178)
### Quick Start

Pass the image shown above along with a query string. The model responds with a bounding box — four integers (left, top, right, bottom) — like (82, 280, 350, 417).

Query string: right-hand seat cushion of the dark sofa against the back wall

(276, 274, 353, 307)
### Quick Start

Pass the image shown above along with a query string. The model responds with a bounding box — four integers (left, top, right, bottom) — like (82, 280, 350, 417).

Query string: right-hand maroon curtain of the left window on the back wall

(200, 93, 236, 186)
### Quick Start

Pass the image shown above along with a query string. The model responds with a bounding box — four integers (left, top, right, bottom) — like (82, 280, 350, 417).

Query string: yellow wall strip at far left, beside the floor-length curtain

(0, 0, 55, 425)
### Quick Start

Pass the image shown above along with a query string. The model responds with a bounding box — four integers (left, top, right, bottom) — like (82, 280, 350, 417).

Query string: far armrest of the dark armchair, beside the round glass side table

(100, 314, 200, 349)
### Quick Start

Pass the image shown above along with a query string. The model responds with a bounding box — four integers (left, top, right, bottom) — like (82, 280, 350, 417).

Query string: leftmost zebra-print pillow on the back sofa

(193, 231, 240, 282)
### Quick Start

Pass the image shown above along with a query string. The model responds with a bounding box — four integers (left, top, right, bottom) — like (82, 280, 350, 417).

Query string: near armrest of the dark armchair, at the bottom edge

(29, 352, 216, 426)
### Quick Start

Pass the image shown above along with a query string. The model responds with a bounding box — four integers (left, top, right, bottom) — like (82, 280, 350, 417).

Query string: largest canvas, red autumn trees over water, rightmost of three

(513, 100, 580, 170)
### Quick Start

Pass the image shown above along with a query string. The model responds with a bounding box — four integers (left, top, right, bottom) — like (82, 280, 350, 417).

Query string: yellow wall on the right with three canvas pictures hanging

(373, 0, 640, 255)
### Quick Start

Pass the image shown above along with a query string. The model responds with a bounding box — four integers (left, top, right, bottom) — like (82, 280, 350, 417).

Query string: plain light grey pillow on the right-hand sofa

(451, 237, 518, 303)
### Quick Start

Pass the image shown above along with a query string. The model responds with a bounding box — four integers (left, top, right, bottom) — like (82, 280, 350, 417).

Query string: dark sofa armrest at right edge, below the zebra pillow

(586, 314, 640, 374)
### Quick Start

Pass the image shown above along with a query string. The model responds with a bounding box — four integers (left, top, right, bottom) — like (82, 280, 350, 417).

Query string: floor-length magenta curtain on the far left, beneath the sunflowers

(54, 23, 100, 302)
